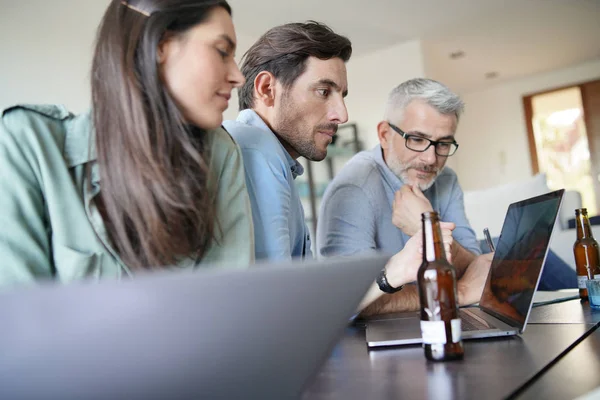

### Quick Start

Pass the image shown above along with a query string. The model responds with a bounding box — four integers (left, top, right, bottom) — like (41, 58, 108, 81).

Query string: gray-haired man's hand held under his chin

(392, 185, 433, 236)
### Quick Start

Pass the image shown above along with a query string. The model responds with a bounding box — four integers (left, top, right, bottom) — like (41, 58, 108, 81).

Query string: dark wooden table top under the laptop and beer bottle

(304, 300, 600, 400)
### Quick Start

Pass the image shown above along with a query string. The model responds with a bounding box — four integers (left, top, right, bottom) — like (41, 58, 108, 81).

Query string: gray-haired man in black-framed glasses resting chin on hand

(317, 79, 491, 315)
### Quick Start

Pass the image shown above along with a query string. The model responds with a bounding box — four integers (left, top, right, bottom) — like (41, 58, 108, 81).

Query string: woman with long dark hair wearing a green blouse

(0, 0, 254, 285)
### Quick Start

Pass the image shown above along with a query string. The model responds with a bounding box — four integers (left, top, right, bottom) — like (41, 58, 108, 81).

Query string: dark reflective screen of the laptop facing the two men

(479, 190, 564, 330)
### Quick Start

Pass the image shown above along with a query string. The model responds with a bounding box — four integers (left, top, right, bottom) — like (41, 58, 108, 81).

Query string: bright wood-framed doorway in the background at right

(523, 80, 600, 215)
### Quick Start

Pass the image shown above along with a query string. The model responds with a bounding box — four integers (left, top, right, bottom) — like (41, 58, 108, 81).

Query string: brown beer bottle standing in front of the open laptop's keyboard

(417, 212, 464, 361)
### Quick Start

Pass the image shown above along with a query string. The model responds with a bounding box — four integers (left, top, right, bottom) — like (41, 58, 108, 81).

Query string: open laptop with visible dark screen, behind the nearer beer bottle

(366, 189, 564, 347)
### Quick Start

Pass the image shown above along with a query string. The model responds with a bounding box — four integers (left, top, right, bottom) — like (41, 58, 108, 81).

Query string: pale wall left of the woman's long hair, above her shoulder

(0, 0, 109, 112)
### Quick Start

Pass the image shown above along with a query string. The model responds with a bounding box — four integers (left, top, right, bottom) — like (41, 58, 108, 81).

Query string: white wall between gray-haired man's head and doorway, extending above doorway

(454, 60, 600, 190)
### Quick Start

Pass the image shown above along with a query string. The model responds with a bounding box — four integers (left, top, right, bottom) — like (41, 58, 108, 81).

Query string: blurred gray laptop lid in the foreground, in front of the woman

(0, 256, 389, 400)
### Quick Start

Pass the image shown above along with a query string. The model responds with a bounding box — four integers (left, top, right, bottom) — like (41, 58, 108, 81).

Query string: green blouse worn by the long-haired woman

(0, 105, 254, 287)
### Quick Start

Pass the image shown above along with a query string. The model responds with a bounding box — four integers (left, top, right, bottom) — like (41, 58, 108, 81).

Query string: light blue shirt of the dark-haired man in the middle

(223, 109, 312, 260)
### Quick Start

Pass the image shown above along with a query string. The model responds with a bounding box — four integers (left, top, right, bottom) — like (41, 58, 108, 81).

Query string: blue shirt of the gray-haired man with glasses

(317, 145, 481, 256)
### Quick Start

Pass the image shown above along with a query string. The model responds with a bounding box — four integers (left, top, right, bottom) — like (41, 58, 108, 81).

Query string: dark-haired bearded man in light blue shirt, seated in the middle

(223, 21, 352, 261)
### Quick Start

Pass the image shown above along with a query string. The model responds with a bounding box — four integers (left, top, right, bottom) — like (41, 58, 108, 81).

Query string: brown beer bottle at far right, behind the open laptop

(573, 208, 600, 300)
